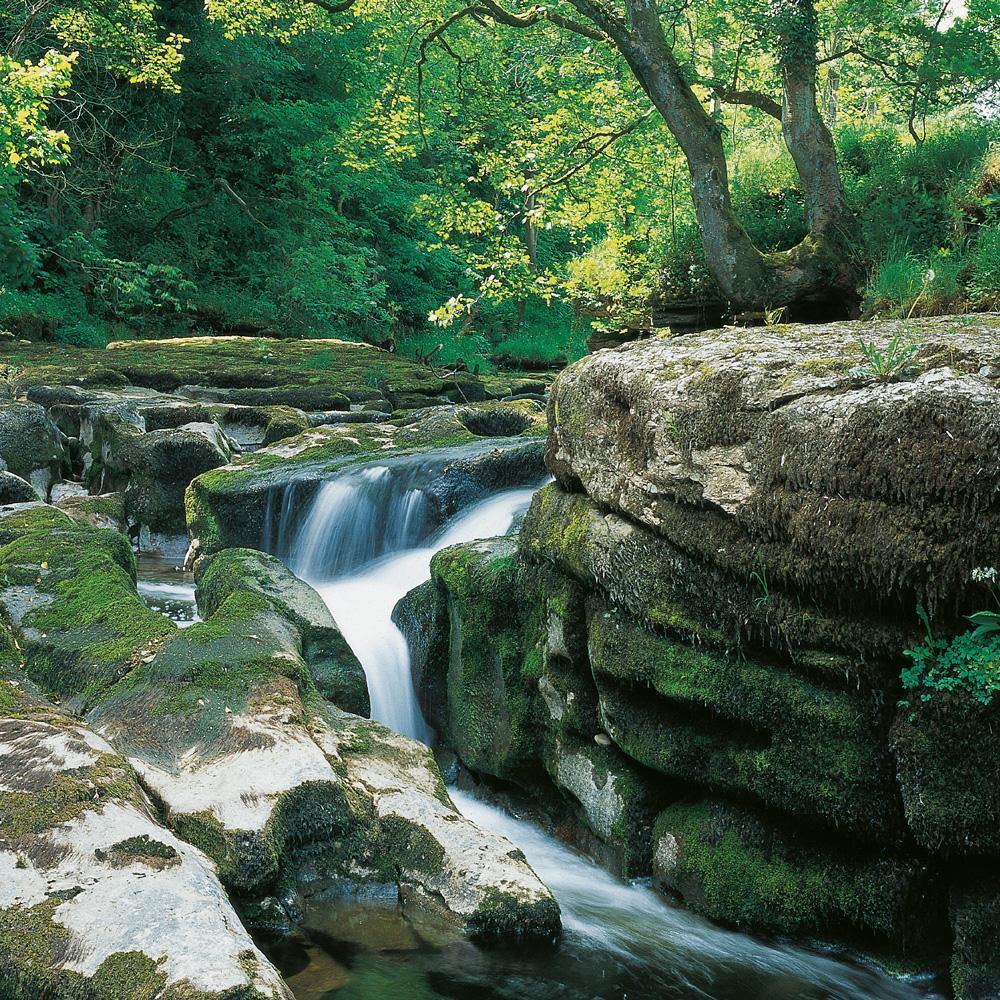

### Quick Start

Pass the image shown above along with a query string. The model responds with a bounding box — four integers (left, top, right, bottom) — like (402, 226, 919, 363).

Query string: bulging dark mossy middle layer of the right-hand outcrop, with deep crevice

(590, 612, 901, 836)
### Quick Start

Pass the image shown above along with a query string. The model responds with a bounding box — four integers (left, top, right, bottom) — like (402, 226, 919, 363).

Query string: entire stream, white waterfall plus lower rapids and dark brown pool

(266, 461, 939, 1000)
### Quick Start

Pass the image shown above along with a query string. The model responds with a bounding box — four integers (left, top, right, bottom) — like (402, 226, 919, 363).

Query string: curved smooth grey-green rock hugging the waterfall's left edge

(195, 549, 371, 716)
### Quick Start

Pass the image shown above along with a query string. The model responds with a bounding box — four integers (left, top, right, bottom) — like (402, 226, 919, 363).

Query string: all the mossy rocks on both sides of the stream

(0, 317, 1000, 1000)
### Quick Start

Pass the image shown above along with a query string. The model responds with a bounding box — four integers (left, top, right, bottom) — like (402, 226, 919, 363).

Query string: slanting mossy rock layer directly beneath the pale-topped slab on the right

(520, 485, 916, 691)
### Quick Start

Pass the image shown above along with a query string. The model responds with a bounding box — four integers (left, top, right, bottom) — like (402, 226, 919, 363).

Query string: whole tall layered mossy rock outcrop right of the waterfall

(410, 317, 1000, 998)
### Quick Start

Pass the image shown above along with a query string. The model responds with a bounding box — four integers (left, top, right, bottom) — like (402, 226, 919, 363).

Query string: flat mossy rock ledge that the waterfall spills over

(186, 401, 544, 553)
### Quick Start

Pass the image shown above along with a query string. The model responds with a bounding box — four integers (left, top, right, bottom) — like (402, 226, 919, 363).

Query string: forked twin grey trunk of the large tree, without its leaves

(576, 0, 860, 315)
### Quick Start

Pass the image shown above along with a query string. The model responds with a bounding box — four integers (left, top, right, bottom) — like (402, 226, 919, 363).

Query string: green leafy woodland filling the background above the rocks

(0, 0, 1000, 357)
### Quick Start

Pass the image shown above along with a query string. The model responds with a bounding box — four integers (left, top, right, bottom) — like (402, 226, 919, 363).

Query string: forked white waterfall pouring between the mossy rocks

(278, 459, 540, 743)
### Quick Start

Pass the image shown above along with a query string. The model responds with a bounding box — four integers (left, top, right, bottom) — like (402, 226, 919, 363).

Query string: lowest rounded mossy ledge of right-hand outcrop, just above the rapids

(654, 800, 947, 959)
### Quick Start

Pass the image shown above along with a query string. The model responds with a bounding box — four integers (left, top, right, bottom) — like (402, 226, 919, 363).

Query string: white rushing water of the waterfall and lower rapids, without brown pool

(272, 467, 932, 1000)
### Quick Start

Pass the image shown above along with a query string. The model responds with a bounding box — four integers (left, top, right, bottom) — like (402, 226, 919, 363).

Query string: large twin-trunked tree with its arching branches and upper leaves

(410, 0, 998, 315)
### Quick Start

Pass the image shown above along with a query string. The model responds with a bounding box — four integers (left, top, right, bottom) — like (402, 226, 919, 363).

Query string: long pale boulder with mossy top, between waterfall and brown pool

(88, 551, 558, 937)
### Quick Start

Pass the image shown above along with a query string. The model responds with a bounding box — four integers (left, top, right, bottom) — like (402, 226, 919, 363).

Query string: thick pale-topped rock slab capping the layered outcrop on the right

(549, 318, 1000, 610)
